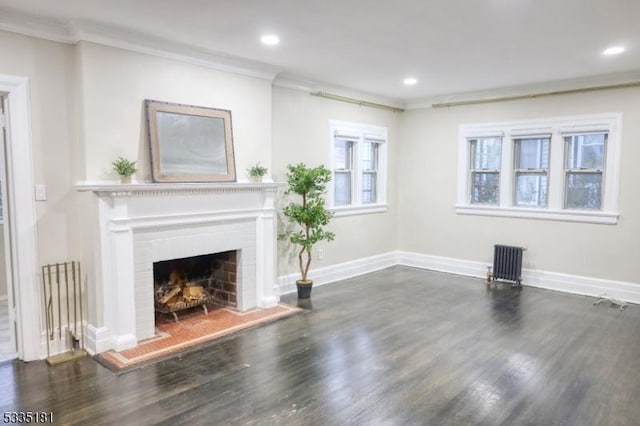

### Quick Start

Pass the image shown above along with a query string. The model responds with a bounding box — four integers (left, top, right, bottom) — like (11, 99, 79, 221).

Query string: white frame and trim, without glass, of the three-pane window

(456, 113, 622, 225)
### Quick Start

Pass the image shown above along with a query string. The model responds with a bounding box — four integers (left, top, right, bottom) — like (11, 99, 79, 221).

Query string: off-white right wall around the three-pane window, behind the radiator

(399, 88, 640, 283)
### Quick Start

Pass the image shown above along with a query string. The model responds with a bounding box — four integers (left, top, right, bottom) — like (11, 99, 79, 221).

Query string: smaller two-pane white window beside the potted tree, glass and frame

(329, 120, 387, 215)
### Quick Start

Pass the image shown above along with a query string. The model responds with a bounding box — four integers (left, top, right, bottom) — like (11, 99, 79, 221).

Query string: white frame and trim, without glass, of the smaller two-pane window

(327, 120, 388, 217)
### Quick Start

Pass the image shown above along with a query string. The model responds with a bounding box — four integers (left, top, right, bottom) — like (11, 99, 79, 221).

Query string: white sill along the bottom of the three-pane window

(456, 205, 619, 225)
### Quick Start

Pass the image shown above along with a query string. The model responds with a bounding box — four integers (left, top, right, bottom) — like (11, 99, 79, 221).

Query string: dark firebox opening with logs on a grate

(153, 250, 238, 320)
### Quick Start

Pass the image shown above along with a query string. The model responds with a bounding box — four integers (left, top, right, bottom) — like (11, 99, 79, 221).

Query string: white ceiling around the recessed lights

(0, 0, 640, 103)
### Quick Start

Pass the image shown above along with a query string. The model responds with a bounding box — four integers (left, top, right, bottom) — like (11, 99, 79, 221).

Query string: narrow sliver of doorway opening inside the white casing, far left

(0, 94, 18, 362)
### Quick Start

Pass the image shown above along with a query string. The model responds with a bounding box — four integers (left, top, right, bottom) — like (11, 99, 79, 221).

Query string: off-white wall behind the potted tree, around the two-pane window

(272, 87, 400, 279)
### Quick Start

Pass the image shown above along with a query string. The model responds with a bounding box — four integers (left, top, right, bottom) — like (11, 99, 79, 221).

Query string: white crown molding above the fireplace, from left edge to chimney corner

(0, 8, 281, 81)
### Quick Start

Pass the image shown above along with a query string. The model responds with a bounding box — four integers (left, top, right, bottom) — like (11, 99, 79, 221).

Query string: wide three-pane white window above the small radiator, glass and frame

(456, 114, 622, 224)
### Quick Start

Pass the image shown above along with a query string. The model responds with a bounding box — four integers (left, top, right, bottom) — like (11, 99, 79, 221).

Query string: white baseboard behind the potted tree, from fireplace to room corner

(278, 252, 398, 294)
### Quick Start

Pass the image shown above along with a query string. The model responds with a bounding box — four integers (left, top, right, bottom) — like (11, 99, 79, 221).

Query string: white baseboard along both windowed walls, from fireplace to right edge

(278, 251, 640, 304)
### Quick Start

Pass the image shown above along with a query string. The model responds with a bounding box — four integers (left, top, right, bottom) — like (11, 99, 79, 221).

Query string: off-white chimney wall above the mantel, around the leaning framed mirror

(77, 42, 271, 181)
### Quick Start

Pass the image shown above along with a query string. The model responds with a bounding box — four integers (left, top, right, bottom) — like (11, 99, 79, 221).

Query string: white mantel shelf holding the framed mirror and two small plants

(76, 182, 285, 197)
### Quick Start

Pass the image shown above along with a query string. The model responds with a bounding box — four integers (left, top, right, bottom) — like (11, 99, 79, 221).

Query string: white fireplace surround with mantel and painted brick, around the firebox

(78, 183, 280, 353)
